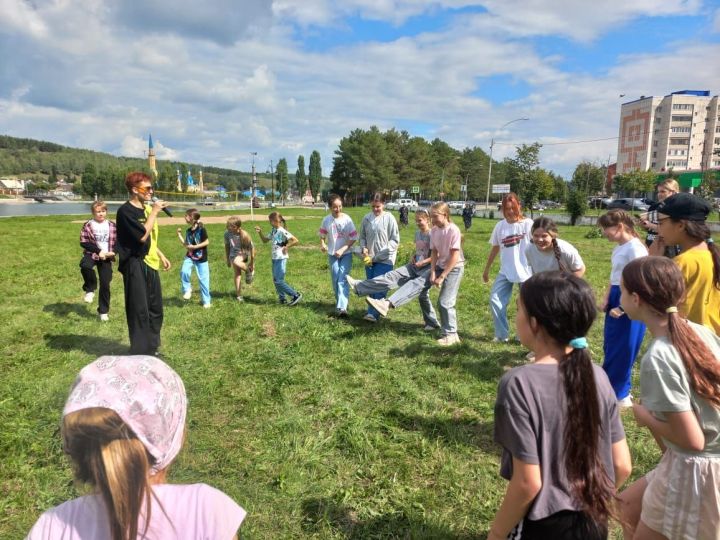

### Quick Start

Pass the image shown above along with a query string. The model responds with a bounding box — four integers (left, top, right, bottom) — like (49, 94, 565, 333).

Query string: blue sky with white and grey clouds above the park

(0, 0, 720, 178)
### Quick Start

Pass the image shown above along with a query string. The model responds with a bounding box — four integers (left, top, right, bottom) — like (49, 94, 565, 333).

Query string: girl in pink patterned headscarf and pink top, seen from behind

(27, 356, 245, 540)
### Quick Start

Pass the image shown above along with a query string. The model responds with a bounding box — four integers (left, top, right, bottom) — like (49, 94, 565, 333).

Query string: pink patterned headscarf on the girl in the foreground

(63, 356, 187, 474)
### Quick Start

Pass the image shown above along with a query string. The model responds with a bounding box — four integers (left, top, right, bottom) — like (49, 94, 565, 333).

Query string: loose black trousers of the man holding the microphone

(121, 257, 163, 355)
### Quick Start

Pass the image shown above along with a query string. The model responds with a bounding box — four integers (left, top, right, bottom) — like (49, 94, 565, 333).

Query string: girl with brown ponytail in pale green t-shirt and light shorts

(620, 257, 720, 540)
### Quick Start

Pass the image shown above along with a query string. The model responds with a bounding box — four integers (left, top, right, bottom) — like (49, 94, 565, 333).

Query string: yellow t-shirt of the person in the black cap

(673, 249, 720, 335)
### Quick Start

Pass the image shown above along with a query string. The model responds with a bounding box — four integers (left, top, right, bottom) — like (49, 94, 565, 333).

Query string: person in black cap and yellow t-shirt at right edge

(657, 193, 720, 334)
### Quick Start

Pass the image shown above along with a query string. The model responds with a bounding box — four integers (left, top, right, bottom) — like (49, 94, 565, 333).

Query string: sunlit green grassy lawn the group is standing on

(0, 208, 684, 539)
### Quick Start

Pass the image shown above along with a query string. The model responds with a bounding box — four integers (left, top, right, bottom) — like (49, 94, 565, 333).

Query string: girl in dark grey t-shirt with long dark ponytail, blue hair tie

(488, 271, 631, 540)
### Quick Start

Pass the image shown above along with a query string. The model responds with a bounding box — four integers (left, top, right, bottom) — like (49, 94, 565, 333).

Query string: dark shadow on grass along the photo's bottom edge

(302, 498, 486, 540)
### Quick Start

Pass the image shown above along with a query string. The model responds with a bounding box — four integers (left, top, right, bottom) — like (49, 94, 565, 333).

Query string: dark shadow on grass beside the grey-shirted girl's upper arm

(385, 410, 499, 454)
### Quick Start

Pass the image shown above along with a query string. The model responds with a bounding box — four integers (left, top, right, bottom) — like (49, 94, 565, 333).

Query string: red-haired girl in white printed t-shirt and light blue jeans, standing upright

(483, 193, 532, 341)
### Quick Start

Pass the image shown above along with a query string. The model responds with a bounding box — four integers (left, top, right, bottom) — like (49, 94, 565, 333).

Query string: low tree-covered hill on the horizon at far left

(0, 135, 250, 193)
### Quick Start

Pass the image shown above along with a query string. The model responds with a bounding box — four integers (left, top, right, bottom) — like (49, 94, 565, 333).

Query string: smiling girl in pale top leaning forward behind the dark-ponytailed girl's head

(525, 216, 585, 277)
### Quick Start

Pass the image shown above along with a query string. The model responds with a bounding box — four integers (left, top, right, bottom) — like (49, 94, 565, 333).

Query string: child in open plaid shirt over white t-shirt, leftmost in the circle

(80, 201, 117, 321)
